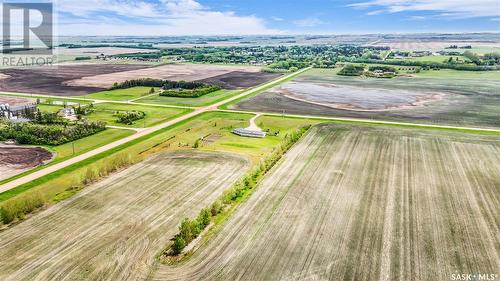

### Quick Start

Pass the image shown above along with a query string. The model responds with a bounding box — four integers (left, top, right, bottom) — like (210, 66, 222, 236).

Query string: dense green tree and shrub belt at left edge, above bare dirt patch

(0, 118, 106, 145)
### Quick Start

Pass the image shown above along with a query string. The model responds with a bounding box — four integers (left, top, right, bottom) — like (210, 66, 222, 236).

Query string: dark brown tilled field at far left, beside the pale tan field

(0, 64, 149, 96)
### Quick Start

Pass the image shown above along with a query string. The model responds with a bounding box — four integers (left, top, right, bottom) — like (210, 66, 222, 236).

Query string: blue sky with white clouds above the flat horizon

(0, 0, 500, 36)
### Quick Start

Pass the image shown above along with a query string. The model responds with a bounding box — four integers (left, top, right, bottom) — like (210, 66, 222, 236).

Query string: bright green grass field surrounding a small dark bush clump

(85, 102, 190, 128)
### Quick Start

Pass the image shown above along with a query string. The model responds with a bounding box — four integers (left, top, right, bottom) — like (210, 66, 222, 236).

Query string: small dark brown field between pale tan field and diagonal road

(196, 71, 281, 90)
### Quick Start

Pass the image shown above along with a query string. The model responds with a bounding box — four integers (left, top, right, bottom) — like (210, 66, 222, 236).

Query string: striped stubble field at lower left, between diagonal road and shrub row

(0, 151, 248, 281)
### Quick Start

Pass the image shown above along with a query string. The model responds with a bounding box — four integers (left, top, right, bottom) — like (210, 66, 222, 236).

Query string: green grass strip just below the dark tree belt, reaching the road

(135, 90, 241, 107)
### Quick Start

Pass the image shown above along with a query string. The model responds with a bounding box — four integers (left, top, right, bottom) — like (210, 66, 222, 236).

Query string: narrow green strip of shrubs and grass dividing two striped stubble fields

(162, 126, 310, 262)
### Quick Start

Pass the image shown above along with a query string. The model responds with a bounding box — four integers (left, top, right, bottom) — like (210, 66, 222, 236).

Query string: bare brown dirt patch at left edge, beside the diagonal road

(0, 144, 52, 180)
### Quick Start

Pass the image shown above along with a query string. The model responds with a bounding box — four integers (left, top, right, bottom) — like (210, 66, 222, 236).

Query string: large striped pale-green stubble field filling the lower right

(151, 125, 500, 280)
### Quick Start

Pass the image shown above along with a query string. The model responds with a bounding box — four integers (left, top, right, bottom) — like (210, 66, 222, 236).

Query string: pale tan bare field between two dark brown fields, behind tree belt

(66, 64, 260, 88)
